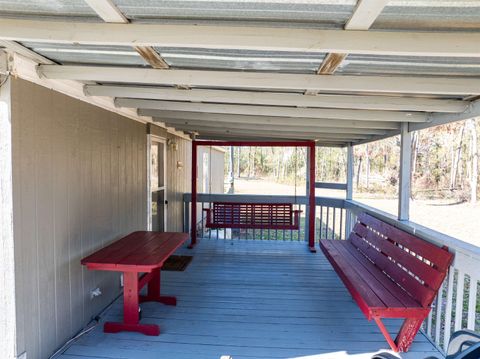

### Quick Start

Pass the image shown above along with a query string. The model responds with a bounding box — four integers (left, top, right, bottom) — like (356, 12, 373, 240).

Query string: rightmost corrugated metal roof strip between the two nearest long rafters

(337, 54, 480, 77)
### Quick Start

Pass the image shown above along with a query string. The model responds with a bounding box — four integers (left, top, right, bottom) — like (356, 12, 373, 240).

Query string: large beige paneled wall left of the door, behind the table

(11, 80, 147, 359)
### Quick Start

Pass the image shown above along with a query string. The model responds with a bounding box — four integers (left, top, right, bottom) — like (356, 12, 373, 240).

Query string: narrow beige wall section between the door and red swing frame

(167, 134, 192, 232)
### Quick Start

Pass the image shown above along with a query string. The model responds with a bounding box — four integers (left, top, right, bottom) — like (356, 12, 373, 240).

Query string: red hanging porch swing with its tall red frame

(190, 141, 315, 252)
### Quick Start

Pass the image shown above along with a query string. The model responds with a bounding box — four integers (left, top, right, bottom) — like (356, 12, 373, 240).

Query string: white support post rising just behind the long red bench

(398, 123, 412, 221)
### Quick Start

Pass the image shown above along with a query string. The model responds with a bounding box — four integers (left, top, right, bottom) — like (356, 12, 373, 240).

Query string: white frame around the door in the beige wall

(147, 134, 168, 232)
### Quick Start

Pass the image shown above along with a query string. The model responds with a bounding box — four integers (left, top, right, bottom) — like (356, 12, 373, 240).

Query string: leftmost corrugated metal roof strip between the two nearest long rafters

(22, 42, 148, 66)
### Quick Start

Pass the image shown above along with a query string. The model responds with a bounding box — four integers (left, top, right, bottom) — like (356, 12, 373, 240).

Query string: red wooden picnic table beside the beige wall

(81, 231, 188, 335)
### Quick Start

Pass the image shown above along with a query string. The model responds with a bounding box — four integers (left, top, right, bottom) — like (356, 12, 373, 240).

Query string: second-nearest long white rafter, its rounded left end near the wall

(37, 65, 480, 95)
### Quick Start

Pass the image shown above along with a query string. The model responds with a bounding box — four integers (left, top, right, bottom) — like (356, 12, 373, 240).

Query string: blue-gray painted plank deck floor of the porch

(60, 239, 441, 359)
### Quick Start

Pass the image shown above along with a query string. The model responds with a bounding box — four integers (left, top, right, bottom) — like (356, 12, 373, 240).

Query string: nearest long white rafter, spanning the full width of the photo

(0, 18, 480, 58)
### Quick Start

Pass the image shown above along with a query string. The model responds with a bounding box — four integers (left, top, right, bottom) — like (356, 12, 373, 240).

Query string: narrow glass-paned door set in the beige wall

(150, 138, 168, 232)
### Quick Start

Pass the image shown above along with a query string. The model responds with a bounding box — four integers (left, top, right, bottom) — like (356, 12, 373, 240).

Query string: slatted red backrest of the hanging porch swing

(213, 202, 293, 226)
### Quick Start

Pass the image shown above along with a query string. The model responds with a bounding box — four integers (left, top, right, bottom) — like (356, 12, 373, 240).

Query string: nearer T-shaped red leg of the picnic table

(103, 272, 160, 335)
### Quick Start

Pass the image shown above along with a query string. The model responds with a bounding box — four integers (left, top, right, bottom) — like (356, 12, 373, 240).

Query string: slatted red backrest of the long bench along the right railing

(349, 213, 453, 307)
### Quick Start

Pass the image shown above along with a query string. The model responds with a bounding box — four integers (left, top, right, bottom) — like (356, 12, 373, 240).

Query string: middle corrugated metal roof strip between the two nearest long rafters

(155, 47, 325, 73)
